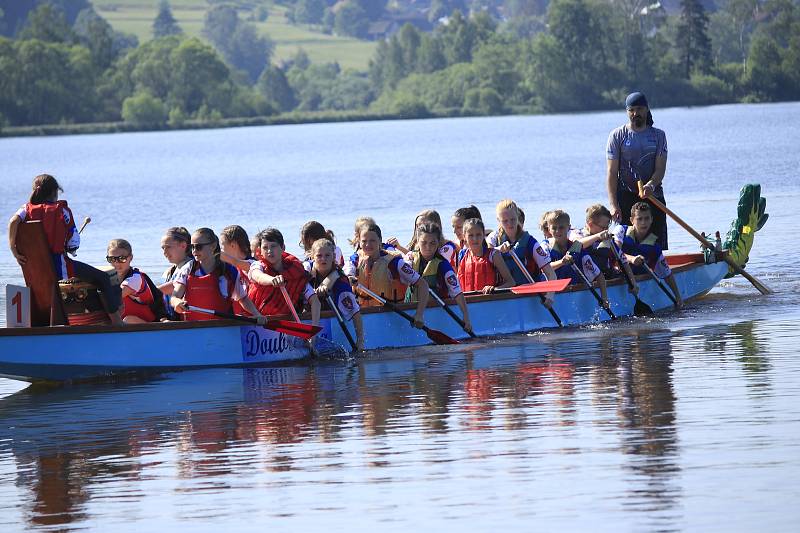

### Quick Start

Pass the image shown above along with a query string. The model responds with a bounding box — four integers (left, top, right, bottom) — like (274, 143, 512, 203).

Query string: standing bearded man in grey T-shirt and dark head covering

(606, 92, 667, 250)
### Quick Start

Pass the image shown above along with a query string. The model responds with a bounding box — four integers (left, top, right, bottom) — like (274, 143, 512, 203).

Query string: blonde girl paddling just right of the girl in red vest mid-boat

(486, 200, 556, 305)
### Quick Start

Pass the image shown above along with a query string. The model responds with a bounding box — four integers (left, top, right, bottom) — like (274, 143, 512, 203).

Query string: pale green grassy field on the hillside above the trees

(92, 0, 375, 70)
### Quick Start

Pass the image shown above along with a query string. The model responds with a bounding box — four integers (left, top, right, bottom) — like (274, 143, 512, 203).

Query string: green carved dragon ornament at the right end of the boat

(722, 183, 769, 278)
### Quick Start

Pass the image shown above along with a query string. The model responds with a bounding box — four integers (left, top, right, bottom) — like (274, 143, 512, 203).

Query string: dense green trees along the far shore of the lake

(0, 0, 800, 131)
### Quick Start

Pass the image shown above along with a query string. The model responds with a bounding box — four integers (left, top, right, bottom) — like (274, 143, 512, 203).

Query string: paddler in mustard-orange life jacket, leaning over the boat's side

(357, 224, 430, 327)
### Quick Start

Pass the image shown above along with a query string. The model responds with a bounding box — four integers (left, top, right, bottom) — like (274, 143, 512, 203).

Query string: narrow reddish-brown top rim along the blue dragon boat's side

(0, 254, 704, 337)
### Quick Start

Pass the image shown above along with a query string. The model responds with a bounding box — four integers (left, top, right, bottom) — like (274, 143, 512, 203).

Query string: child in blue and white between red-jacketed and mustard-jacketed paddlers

(310, 239, 364, 351)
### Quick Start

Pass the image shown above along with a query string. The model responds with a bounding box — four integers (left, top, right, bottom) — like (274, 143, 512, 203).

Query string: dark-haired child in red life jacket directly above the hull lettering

(249, 228, 320, 326)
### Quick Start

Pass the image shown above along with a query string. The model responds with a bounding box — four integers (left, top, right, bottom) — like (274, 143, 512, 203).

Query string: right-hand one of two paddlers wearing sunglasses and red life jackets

(170, 228, 264, 320)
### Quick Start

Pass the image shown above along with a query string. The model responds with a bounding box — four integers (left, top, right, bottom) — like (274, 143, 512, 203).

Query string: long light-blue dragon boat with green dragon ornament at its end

(0, 185, 768, 382)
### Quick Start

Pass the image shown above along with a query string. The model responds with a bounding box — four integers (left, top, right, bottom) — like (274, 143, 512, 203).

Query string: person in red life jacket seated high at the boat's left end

(8, 174, 123, 325)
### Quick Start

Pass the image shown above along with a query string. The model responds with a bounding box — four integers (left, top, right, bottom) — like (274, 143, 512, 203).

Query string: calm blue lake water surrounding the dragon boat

(0, 103, 800, 532)
